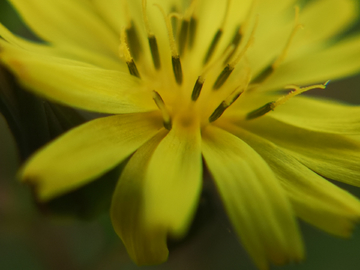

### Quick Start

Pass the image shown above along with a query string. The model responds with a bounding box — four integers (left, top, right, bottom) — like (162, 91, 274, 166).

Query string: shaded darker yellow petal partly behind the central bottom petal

(110, 130, 169, 265)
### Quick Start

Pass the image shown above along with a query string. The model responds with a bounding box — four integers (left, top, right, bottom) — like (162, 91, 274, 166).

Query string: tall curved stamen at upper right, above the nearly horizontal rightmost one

(252, 6, 303, 84)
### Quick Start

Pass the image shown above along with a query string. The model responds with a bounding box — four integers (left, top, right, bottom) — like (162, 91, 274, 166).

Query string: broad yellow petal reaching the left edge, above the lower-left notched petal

(0, 42, 156, 113)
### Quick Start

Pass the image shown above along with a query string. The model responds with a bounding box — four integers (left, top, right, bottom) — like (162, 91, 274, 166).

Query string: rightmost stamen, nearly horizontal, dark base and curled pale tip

(246, 81, 330, 120)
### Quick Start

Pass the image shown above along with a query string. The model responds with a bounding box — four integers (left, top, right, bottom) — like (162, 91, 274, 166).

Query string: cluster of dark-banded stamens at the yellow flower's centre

(120, 0, 326, 130)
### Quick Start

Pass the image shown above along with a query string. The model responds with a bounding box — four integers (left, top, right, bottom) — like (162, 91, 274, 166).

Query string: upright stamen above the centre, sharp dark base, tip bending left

(154, 4, 183, 85)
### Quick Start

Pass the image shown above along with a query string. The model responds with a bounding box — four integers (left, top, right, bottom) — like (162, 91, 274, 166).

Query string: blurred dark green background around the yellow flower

(0, 0, 360, 270)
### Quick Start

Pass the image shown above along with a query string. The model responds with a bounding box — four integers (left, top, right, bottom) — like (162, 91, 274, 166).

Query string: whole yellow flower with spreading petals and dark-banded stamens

(0, 0, 360, 269)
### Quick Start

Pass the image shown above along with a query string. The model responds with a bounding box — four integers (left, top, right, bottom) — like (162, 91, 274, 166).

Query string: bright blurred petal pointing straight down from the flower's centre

(144, 121, 202, 238)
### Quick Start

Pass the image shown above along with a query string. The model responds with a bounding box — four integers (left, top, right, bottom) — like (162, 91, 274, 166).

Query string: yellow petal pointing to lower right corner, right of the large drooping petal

(221, 123, 360, 237)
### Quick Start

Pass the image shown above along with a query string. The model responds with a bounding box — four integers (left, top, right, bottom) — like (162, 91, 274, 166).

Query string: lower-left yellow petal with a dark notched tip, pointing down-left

(20, 112, 162, 201)
